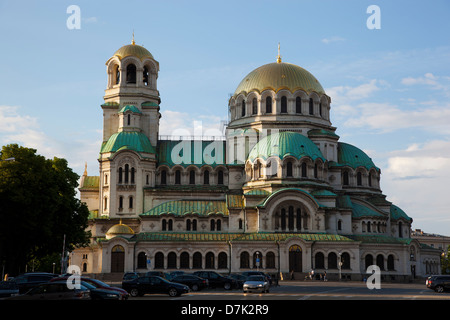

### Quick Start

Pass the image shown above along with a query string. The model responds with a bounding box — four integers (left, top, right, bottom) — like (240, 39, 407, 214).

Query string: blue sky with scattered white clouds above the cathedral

(0, 0, 450, 235)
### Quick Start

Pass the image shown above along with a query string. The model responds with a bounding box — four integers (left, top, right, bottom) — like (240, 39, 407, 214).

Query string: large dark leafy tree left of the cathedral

(0, 144, 89, 274)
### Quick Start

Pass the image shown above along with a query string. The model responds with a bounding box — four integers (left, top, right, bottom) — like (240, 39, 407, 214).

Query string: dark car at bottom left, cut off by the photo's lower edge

(6, 281, 91, 300)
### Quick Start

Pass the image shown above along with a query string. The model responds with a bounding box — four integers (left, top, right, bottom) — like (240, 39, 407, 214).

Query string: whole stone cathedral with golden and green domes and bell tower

(70, 39, 440, 281)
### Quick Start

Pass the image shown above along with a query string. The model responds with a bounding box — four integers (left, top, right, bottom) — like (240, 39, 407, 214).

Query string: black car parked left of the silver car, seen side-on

(122, 276, 189, 297)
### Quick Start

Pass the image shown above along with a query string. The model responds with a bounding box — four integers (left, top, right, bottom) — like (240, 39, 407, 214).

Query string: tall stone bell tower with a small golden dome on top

(99, 37, 161, 218)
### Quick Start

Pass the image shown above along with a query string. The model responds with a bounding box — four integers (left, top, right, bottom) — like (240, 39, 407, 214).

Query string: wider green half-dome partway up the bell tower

(100, 131, 155, 153)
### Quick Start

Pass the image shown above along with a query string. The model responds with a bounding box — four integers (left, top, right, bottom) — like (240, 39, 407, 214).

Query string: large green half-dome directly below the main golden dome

(248, 131, 326, 162)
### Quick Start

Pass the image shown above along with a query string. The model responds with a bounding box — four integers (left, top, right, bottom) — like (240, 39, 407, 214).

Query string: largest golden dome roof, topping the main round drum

(234, 62, 325, 96)
